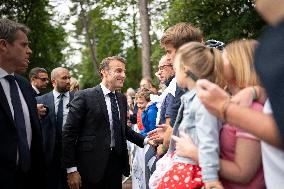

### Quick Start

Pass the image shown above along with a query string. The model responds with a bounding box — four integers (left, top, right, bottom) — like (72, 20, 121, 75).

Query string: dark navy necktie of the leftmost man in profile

(5, 75, 31, 172)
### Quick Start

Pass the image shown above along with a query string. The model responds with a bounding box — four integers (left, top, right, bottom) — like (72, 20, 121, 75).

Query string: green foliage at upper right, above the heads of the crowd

(163, 0, 264, 43)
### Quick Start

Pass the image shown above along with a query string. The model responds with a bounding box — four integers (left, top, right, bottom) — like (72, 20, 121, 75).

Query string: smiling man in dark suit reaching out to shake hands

(62, 56, 151, 189)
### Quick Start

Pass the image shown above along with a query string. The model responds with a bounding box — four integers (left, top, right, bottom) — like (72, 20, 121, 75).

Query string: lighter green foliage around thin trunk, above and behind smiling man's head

(76, 6, 124, 88)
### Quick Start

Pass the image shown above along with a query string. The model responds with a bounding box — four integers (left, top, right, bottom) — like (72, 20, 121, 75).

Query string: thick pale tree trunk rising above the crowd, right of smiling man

(138, 0, 151, 78)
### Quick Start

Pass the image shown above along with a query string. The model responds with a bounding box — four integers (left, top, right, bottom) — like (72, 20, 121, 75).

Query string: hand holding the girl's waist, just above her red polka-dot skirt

(172, 132, 198, 162)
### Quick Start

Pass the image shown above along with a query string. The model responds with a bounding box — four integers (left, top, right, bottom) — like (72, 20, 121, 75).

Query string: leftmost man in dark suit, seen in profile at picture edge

(0, 19, 45, 189)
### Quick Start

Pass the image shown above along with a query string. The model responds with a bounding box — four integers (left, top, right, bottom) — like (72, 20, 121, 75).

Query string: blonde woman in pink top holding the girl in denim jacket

(173, 40, 265, 189)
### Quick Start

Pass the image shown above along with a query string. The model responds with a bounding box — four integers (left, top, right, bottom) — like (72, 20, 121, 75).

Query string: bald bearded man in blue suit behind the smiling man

(37, 67, 74, 189)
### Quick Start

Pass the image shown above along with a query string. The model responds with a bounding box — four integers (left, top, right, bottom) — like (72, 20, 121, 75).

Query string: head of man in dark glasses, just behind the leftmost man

(29, 67, 49, 96)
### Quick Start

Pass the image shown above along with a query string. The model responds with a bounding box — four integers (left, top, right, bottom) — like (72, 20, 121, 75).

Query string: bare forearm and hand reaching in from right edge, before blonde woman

(197, 79, 282, 147)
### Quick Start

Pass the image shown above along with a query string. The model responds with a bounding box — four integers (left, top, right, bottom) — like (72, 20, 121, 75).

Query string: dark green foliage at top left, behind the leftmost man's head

(0, 0, 67, 75)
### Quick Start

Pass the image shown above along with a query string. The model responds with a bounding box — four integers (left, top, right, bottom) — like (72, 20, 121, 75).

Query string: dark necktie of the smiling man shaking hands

(108, 92, 122, 153)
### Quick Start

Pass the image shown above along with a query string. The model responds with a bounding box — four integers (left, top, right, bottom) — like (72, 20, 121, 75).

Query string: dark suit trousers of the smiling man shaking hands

(82, 150, 122, 189)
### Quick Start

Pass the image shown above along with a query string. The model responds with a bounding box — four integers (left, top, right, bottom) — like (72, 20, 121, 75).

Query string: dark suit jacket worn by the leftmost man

(0, 74, 45, 189)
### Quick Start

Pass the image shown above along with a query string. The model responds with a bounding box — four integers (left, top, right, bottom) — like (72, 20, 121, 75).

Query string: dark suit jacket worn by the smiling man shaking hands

(62, 85, 144, 183)
